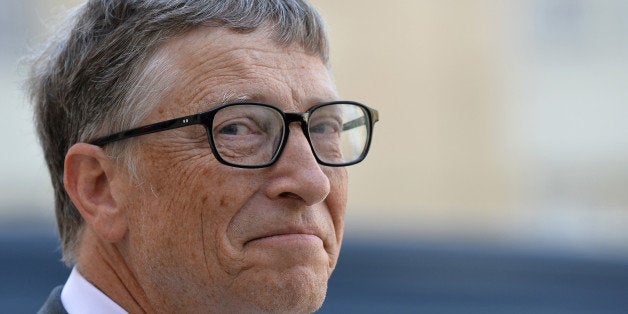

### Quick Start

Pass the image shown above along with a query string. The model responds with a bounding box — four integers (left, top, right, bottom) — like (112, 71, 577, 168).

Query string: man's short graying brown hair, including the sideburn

(28, 0, 328, 264)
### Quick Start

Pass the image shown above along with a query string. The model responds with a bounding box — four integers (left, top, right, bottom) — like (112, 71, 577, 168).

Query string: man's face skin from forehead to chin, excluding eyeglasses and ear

(115, 29, 347, 312)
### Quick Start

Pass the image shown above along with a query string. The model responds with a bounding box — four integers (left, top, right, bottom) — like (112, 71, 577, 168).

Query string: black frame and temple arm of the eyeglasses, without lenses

(89, 100, 379, 169)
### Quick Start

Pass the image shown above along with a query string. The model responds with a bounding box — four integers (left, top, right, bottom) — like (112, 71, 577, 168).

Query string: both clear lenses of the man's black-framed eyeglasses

(211, 104, 370, 166)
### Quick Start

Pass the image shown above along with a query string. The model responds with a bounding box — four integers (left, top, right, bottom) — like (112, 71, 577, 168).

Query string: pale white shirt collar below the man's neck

(61, 267, 128, 314)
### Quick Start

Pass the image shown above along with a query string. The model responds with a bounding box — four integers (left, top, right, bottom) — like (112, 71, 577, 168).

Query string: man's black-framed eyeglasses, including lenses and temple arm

(90, 101, 379, 168)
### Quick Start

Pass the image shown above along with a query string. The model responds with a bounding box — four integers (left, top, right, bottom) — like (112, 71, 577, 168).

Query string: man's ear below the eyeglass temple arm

(63, 143, 127, 243)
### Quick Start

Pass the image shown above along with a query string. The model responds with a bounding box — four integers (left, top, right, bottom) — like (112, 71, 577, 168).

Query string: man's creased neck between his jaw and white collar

(77, 227, 155, 313)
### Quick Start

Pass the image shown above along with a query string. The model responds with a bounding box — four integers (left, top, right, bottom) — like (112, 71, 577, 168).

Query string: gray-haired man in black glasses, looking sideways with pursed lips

(30, 0, 378, 313)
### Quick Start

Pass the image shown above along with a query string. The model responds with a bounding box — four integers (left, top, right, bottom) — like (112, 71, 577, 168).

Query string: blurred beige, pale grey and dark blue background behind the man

(0, 0, 628, 313)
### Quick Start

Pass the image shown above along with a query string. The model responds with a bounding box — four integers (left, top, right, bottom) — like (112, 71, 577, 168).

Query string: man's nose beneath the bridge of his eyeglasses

(266, 124, 330, 206)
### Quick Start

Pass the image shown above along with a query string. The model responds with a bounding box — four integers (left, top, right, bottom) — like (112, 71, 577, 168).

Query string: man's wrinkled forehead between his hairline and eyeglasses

(157, 28, 337, 113)
